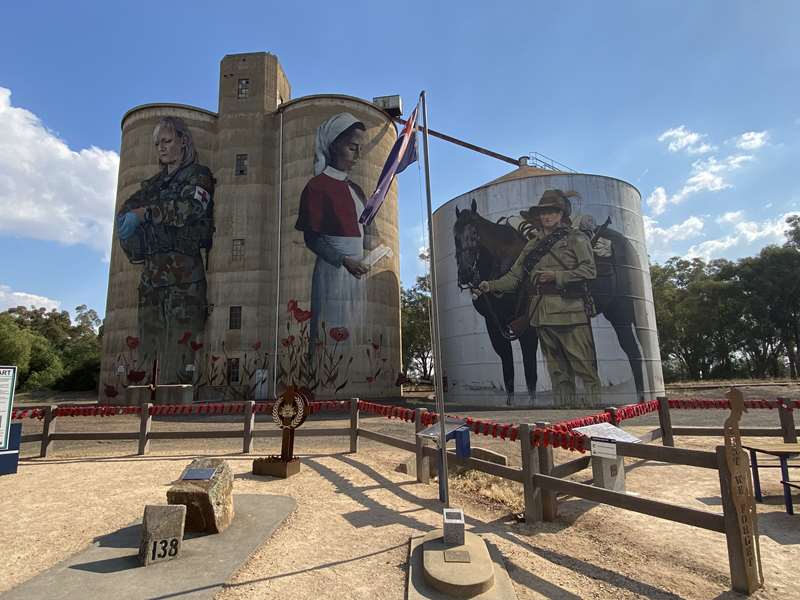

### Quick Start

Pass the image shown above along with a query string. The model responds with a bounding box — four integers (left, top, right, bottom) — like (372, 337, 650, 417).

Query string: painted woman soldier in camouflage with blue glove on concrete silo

(117, 117, 214, 383)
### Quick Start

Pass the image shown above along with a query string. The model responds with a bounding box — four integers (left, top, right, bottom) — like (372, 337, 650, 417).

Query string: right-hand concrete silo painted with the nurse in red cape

(276, 95, 400, 398)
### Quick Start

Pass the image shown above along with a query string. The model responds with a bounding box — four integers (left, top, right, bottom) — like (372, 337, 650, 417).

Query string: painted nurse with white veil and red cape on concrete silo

(295, 112, 374, 354)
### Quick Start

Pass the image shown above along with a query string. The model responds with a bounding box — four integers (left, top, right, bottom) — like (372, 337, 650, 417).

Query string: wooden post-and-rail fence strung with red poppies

(12, 397, 800, 592)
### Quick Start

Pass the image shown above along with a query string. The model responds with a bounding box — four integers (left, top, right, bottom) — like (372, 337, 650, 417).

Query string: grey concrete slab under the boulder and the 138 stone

(0, 494, 297, 600)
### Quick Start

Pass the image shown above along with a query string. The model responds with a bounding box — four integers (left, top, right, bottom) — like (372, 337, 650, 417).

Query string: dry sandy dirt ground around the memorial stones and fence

(0, 382, 800, 600)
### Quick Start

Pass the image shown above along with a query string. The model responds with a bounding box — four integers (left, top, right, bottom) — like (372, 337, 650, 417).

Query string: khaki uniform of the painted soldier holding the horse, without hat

(488, 199, 600, 406)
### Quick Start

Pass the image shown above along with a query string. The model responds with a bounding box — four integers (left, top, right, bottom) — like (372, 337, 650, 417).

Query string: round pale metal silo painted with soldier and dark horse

(433, 166, 664, 407)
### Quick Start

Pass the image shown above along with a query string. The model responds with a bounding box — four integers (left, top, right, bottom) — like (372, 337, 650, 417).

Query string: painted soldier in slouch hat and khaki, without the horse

(478, 190, 600, 406)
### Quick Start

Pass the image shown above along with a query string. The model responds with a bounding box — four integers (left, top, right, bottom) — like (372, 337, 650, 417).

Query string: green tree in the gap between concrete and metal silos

(400, 275, 433, 379)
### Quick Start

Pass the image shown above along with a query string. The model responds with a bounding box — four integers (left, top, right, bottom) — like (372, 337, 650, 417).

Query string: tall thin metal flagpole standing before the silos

(420, 90, 450, 507)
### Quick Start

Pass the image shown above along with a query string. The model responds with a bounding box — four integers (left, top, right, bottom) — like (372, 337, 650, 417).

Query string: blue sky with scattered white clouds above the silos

(0, 0, 800, 322)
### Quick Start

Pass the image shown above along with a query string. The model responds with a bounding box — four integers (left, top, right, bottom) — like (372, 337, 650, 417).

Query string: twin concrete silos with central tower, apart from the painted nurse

(100, 53, 400, 403)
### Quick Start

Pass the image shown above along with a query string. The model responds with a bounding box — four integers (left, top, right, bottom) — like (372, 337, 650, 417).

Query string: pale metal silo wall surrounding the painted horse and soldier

(433, 174, 664, 407)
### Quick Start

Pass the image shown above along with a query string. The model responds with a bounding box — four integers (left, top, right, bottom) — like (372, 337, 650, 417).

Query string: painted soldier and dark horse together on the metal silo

(453, 184, 647, 406)
